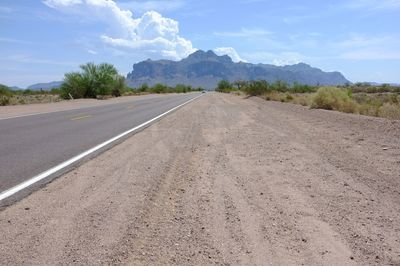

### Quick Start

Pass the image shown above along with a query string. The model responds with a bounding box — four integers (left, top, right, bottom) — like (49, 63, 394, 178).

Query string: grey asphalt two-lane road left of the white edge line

(0, 93, 199, 193)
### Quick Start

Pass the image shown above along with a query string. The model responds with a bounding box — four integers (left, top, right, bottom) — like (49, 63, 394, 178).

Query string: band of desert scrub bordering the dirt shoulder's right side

(216, 80, 400, 119)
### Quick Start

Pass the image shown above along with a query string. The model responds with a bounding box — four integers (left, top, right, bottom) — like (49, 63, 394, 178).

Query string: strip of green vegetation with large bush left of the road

(0, 63, 203, 106)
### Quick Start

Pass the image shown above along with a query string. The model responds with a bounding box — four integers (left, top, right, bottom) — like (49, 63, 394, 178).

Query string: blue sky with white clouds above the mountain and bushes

(0, 0, 400, 87)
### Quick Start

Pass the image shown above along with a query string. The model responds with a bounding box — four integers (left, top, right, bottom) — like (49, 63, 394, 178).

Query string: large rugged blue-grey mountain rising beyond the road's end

(127, 50, 349, 89)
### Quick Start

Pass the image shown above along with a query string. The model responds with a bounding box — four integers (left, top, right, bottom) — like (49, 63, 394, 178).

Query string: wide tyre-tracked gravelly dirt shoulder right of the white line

(0, 93, 400, 265)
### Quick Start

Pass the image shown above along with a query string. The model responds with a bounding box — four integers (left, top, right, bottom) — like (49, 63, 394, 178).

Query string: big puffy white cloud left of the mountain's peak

(43, 0, 196, 59)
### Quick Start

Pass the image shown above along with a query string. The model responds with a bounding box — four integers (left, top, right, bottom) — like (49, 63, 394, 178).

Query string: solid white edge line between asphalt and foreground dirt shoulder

(0, 94, 203, 201)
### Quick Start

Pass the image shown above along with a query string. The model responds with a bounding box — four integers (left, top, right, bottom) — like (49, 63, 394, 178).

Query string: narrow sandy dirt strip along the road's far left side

(0, 94, 167, 119)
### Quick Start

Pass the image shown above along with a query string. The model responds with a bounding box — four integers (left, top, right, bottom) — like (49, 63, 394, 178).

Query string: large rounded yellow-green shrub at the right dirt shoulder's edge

(311, 87, 357, 113)
